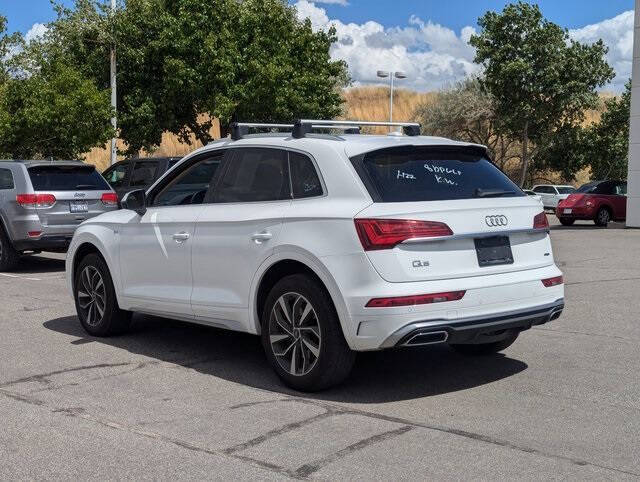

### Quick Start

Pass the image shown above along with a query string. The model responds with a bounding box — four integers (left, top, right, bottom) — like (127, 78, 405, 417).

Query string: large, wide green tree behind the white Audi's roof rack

(51, 0, 348, 153)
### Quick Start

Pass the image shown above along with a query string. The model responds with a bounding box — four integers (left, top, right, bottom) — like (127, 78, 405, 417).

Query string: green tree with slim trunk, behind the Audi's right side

(470, 2, 614, 185)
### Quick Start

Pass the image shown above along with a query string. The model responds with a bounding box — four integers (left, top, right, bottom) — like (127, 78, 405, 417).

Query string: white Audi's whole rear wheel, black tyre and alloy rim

(261, 274, 355, 391)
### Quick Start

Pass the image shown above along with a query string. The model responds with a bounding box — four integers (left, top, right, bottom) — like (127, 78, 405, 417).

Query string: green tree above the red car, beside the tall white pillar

(584, 80, 631, 179)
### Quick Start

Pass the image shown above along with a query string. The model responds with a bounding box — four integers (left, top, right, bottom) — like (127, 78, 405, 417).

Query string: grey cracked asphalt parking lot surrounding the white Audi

(0, 218, 640, 480)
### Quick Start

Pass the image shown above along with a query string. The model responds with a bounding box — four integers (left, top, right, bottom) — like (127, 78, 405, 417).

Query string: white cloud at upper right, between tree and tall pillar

(569, 10, 633, 92)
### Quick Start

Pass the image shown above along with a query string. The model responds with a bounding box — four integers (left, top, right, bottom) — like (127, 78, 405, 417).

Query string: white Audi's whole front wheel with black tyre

(74, 254, 131, 336)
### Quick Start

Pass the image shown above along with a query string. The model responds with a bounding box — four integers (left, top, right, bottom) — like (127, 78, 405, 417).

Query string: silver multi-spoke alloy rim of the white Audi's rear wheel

(269, 292, 322, 376)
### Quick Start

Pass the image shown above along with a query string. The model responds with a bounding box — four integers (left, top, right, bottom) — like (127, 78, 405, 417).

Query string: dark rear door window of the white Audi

(215, 148, 291, 203)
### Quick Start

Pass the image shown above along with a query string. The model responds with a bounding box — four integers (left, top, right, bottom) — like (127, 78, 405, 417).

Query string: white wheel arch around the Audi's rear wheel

(249, 250, 349, 340)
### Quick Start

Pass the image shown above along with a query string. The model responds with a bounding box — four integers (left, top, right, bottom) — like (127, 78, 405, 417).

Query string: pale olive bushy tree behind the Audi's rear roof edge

(415, 78, 519, 174)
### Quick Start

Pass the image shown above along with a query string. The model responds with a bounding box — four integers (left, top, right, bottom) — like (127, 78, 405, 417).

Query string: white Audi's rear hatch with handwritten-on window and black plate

(352, 146, 553, 282)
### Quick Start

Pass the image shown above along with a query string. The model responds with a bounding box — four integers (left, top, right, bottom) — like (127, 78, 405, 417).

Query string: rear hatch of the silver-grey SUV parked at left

(28, 163, 117, 227)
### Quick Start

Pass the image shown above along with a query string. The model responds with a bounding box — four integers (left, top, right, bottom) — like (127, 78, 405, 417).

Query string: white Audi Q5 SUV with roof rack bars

(66, 121, 564, 391)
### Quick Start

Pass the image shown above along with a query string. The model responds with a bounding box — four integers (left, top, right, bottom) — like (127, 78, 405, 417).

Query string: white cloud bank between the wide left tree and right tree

(295, 0, 479, 91)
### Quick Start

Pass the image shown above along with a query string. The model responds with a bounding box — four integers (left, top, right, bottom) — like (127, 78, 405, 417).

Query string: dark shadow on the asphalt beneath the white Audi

(44, 315, 527, 403)
